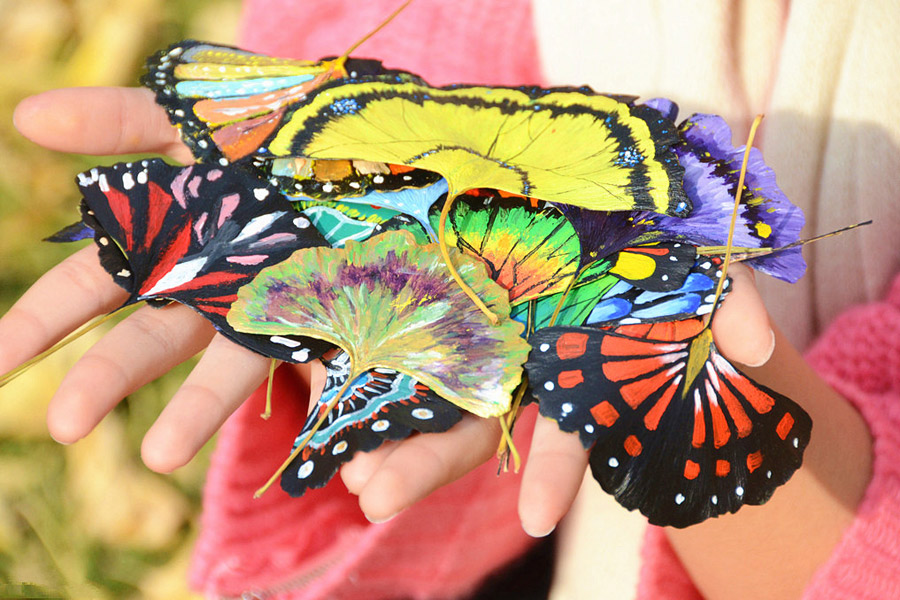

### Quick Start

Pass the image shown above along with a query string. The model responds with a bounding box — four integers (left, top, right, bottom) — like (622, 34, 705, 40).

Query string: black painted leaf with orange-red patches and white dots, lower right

(526, 319, 812, 527)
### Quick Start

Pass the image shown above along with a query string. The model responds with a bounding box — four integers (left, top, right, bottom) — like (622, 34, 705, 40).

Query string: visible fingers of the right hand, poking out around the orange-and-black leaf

(341, 265, 775, 536)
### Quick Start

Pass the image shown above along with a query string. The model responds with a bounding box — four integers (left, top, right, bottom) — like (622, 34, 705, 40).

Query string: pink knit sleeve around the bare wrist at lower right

(638, 276, 900, 600)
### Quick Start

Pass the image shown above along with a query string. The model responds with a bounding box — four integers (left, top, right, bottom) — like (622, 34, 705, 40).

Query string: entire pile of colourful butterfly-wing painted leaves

(57, 41, 811, 526)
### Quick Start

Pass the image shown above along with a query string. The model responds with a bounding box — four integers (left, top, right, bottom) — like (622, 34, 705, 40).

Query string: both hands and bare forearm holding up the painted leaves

(0, 88, 871, 598)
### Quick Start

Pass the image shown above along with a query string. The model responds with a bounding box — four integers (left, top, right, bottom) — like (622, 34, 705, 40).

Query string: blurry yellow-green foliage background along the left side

(0, 0, 240, 599)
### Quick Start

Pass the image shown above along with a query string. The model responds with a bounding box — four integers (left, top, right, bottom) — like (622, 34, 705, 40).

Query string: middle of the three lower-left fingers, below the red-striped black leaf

(47, 304, 213, 443)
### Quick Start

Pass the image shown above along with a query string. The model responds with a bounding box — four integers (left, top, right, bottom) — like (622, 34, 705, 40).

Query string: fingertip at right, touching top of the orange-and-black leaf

(712, 265, 775, 367)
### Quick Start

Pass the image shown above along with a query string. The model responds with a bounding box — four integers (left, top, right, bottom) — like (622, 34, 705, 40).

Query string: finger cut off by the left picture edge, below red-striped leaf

(0, 246, 128, 373)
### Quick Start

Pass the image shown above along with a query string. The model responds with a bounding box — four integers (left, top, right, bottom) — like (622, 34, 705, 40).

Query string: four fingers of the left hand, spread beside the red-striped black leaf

(0, 88, 282, 471)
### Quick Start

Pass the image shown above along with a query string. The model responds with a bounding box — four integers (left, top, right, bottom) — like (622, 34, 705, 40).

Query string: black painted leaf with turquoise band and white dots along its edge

(281, 352, 462, 496)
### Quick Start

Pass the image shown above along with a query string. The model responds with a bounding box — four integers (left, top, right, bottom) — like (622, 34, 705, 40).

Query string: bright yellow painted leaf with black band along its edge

(257, 77, 691, 216)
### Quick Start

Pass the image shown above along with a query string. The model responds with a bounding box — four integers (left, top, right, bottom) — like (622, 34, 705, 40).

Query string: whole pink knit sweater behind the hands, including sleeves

(191, 0, 900, 600)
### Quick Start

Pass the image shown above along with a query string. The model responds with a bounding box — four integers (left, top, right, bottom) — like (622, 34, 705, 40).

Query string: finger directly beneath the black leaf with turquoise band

(345, 414, 500, 523)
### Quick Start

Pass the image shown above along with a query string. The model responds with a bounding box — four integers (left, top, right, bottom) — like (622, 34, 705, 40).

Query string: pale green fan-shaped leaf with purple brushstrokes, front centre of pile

(228, 231, 529, 417)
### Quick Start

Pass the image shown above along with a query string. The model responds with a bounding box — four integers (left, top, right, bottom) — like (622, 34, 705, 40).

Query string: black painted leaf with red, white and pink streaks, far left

(71, 159, 330, 362)
